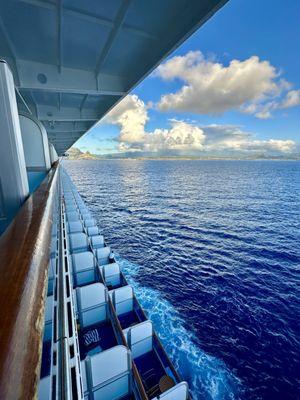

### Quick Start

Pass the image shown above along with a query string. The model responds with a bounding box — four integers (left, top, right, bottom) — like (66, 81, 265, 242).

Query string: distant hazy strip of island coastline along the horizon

(66, 147, 300, 160)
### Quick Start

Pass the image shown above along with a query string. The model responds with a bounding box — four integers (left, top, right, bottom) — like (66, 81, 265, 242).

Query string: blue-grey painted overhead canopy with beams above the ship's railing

(0, 0, 227, 154)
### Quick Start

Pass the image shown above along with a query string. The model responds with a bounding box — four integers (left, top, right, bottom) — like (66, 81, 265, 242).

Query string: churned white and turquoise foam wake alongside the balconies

(118, 257, 241, 400)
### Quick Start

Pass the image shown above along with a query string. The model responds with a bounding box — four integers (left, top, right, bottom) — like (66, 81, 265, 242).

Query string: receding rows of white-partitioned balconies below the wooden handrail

(39, 169, 189, 400)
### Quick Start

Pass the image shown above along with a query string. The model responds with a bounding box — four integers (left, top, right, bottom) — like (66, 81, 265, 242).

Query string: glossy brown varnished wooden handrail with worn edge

(0, 163, 59, 400)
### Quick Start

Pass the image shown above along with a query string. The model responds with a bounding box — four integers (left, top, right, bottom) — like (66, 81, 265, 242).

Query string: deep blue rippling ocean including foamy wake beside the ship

(64, 160, 300, 400)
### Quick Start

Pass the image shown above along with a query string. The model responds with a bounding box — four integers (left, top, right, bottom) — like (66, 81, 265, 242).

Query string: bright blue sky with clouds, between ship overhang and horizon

(75, 0, 300, 155)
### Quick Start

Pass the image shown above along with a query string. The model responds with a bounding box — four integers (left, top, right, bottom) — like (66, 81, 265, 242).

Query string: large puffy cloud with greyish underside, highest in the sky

(155, 51, 299, 118)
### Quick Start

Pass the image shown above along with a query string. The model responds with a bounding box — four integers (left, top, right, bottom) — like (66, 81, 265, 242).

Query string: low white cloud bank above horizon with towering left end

(106, 95, 295, 154)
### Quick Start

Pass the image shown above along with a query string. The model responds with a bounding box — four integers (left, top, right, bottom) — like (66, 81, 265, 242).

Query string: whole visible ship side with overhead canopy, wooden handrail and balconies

(0, 0, 226, 400)
